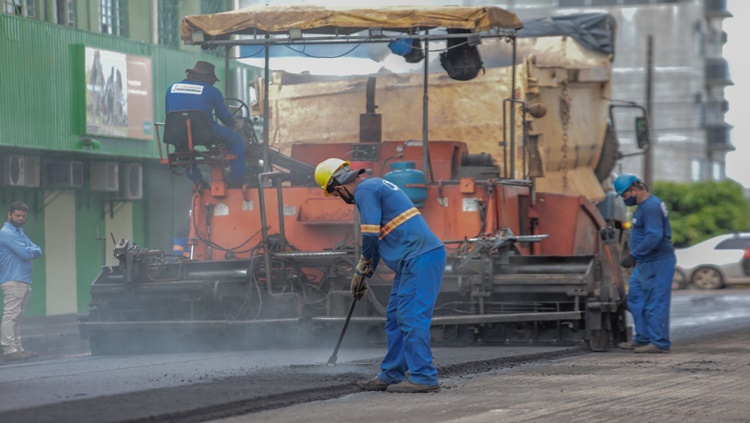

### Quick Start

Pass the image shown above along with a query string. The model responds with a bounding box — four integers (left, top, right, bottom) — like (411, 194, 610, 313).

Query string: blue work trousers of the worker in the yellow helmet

(378, 247, 446, 385)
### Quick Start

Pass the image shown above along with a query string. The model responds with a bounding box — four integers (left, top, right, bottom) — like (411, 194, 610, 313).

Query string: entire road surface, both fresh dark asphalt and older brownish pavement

(0, 290, 750, 423)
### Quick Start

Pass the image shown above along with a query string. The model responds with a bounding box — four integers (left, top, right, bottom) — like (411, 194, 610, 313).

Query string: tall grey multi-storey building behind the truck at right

(490, 0, 734, 182)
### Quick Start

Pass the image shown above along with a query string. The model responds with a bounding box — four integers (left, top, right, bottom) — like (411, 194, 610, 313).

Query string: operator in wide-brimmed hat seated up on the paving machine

(165, 61, 246, 188)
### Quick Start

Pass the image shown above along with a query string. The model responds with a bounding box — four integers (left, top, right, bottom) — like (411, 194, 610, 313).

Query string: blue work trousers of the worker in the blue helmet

(628, 255, 676, 349)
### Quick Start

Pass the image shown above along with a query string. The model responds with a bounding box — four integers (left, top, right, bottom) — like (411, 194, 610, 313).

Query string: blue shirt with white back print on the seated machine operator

(164, 79, 235, 128)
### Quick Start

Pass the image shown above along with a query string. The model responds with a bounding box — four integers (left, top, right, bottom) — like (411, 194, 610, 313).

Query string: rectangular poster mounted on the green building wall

(85, 47, 154, 140)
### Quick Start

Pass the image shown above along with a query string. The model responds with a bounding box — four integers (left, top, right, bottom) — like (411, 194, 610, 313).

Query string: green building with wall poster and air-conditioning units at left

(0, 0, 255, 315)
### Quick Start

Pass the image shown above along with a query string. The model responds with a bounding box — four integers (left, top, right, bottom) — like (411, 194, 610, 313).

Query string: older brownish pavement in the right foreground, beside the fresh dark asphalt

(236, 327, 750, 423)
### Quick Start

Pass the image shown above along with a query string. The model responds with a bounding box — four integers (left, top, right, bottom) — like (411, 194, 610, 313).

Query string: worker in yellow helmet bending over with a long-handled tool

(315, 159, 446, 392)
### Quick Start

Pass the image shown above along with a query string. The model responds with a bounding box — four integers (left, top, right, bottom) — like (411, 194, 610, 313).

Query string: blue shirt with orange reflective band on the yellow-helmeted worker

(354, 178, 443, 271)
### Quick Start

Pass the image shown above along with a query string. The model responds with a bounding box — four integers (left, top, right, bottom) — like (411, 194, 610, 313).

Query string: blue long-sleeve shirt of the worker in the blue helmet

(630, 195, 674, 262)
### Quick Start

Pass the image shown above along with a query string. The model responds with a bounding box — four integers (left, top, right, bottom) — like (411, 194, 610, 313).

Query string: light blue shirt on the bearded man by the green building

(0, 222, 42, 284)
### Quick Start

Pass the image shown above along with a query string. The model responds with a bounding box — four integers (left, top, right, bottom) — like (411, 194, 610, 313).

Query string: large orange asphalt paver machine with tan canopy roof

(80, 6, 626, 354)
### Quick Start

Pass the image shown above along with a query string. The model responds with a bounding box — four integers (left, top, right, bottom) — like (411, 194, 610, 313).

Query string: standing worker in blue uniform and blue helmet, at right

(614, 174, 676, 353)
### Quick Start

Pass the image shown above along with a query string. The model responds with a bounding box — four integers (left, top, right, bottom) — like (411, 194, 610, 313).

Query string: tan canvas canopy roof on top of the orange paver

(181, 5, 523, 41)
